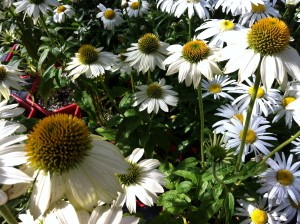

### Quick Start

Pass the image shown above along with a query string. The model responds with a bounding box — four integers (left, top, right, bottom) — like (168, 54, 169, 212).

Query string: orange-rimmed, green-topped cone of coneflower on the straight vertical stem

(182, 40, 209, 63)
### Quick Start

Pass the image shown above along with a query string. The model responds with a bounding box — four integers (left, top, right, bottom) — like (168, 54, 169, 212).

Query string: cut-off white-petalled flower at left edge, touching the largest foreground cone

(0, 120, 33, 185)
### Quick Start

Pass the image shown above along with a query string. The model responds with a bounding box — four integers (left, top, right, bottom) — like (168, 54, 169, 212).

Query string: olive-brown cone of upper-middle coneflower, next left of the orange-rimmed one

(138, 33, 160, 54)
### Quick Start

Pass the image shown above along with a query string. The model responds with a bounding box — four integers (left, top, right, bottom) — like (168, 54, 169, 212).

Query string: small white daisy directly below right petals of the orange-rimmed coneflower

(201, 75, 237, 100)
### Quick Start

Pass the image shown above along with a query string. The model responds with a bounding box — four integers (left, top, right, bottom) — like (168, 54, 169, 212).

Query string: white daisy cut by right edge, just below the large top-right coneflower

(272, 84, 300, 128)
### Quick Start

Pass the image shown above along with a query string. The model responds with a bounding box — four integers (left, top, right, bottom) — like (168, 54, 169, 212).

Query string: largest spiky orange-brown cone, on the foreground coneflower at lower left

(25, 114, 92, 174)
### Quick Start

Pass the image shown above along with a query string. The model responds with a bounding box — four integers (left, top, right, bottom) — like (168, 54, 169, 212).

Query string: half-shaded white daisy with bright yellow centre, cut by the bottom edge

(235, 196, 280, 224)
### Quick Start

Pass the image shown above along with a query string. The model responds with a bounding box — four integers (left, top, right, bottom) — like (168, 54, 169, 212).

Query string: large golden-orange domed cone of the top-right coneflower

(248, 18, 290, 55)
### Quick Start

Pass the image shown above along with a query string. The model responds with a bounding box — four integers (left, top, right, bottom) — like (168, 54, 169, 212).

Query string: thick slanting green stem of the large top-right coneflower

(235, 71, 261, 173)
